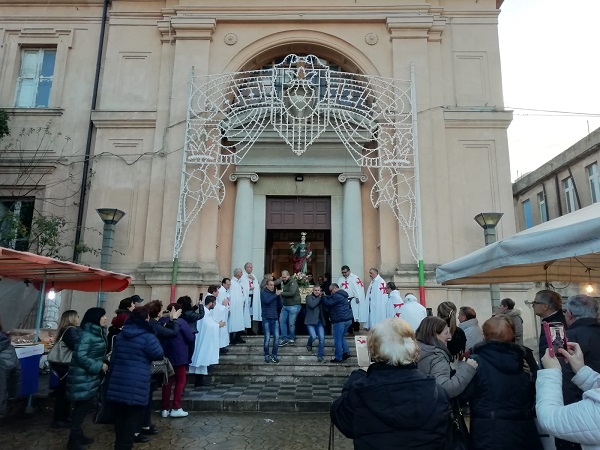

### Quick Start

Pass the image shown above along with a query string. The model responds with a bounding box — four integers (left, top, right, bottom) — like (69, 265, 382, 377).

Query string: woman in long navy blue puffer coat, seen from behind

(106, 307, 163, 450)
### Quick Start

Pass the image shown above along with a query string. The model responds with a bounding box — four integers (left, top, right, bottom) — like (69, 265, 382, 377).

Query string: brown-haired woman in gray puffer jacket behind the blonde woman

(416, 316, 477, 398)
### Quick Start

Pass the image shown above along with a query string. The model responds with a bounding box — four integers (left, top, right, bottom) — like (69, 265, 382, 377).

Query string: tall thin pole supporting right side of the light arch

(410, 63, 426, 306)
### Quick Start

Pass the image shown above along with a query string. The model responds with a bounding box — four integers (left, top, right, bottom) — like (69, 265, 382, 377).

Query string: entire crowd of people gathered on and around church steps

(0, 263, 600, 450)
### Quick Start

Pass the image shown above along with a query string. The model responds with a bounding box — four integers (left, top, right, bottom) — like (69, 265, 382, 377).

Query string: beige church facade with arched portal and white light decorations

(0, 0, 521, 324)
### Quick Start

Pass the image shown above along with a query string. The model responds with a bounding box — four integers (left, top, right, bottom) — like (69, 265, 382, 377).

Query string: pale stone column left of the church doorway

(229, 172, 258, 275)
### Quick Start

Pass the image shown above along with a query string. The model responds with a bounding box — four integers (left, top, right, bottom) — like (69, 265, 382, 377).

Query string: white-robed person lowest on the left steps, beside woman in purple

(190, 295, 226, 386)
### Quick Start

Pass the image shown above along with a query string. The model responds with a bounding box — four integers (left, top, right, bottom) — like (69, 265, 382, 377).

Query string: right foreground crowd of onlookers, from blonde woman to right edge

(331, 290, 600, 450)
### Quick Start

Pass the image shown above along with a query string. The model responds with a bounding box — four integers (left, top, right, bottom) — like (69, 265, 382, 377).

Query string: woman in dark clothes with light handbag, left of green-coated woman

(50, 309, 81, 428)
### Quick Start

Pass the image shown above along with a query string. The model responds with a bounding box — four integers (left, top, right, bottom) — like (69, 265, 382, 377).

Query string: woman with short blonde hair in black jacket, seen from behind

(330, 317, 450, 450)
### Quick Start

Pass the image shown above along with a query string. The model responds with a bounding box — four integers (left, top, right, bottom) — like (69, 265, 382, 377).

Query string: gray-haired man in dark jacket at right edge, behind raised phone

(556, 294, 600, 450)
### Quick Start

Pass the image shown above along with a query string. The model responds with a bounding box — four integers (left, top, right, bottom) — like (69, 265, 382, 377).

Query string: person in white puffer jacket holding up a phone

(535, 342, 600, 450)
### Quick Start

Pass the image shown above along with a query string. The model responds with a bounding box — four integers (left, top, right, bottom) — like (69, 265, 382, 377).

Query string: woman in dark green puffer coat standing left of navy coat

(67, 308, 108, 450)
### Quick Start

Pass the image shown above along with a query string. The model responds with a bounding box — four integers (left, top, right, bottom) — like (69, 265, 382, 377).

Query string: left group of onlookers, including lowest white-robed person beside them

(9, 285, 229, 450)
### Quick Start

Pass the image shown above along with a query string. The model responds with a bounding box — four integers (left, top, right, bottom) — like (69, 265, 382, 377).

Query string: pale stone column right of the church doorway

(340, 172, 367, 279)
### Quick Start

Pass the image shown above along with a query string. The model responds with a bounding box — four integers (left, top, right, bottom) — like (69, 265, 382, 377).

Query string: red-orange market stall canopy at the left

(0, 247, 131, 292)
